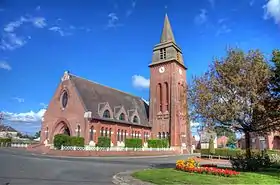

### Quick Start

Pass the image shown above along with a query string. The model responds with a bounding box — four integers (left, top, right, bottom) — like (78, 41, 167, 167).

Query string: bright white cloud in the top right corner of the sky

(263, 0, 280, 24)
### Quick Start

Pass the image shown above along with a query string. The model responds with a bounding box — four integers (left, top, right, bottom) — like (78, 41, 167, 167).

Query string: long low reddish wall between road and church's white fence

(46, 150, 180, 157)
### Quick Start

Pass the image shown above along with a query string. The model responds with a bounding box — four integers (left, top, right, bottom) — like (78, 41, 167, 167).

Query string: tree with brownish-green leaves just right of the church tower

(189, 49, 278, 157)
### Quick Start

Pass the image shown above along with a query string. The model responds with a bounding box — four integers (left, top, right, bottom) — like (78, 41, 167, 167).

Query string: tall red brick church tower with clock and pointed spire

(149, 15, 191, 151)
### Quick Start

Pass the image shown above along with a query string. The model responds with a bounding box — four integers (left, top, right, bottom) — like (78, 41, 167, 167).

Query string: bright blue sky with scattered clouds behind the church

(0, 0, 280, 136)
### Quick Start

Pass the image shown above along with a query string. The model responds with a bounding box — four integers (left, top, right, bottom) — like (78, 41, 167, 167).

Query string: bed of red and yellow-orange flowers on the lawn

(176, 158, 240, 177)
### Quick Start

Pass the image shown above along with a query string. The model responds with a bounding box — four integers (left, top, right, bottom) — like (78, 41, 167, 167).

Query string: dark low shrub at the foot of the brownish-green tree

(230, 152, 271, 171)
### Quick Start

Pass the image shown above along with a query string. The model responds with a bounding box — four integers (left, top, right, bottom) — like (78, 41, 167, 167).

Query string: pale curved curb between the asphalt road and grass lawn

(112, 168, 154, 185)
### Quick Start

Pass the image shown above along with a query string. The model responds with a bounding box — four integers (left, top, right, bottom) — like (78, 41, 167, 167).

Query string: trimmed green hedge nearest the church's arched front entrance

(53, 134, 85, 149)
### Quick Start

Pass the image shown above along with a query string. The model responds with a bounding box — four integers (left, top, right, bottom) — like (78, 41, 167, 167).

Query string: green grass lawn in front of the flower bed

(132, 168, 280, 185)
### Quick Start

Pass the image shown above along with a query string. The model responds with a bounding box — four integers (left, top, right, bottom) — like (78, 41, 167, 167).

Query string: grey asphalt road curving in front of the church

(0, 148, 190, 185)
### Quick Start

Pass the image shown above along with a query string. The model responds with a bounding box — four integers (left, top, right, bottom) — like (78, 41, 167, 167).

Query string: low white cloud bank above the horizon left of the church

(3, 109, 46, 123)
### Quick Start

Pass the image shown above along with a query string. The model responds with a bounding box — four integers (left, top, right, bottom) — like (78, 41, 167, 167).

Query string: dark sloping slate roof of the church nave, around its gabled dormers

(69, 74, 151, 127)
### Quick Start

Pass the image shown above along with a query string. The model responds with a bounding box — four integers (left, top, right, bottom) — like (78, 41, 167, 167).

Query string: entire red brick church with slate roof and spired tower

(41, 15, 192, 148)
